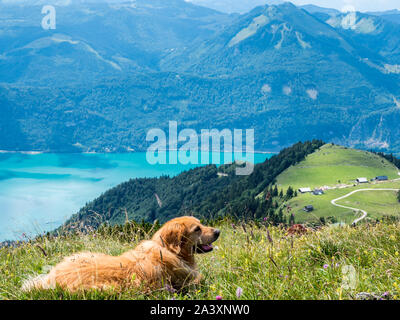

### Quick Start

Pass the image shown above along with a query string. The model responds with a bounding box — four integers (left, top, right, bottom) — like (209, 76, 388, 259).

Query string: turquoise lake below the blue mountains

(0, 152, 272, 242)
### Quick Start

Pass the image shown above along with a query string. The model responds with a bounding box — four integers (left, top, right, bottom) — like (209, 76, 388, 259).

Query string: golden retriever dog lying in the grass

(22, 216, 220, 292)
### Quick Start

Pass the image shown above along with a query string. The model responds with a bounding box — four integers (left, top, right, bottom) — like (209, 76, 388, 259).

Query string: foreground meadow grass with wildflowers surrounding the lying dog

(0, 221, 400, 300)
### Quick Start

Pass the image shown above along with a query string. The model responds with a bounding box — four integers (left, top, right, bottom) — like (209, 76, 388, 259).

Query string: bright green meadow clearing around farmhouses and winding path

(277, 144, 400, 224)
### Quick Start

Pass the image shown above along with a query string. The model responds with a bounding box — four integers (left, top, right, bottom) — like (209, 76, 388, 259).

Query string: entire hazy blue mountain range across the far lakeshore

(0, 0, 400, 152)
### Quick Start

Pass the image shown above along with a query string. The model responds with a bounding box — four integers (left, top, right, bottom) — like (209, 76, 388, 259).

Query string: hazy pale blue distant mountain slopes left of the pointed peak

(0, 0, 230, 87)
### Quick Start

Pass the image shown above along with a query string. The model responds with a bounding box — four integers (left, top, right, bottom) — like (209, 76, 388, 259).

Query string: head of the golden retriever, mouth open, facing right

(153, 216, 220, 256)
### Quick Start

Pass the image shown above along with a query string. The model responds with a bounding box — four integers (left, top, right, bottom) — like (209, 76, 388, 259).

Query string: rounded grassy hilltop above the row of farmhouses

(277, 144, 399, 189)
